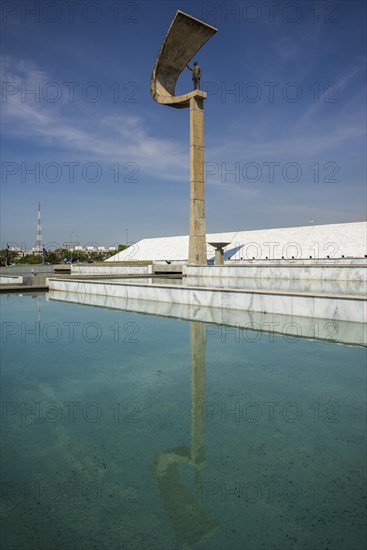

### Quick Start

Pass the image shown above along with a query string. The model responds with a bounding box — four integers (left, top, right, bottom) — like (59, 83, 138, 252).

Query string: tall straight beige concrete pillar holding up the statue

(188, 95, 207, 265)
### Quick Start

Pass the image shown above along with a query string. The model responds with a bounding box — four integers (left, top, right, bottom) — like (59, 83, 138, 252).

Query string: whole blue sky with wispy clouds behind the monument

(1, 0, 366, 250)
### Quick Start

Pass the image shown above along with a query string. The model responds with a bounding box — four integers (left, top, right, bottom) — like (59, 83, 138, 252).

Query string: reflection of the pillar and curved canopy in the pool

(153, 321, 218, 545)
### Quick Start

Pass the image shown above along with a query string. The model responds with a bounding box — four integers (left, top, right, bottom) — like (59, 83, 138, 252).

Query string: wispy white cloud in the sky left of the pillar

(3, 59, 188, 181)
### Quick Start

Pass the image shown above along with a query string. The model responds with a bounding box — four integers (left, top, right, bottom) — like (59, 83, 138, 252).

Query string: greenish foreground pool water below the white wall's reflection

(1, 295, 366, 550)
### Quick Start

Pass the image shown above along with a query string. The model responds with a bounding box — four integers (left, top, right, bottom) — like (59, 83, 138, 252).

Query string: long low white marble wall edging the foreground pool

(47, 278, 367, 323)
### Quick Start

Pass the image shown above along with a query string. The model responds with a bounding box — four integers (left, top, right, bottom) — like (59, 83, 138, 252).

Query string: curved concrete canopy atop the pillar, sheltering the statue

(150, 11, 217, 109)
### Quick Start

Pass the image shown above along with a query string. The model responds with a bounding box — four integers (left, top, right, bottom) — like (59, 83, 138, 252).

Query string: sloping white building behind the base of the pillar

(107, 222, 367, 262)
